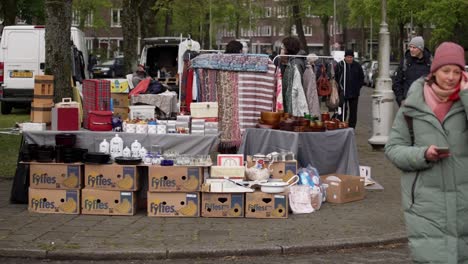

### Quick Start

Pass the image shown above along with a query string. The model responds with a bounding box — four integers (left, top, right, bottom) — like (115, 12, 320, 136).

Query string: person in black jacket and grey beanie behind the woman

(392, 36, 432, 106)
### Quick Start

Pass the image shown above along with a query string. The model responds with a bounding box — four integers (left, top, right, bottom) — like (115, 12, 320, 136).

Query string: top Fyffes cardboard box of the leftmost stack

(29, 162, 83, 189)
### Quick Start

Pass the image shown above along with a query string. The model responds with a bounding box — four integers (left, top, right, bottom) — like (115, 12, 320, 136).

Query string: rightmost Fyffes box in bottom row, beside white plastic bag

(245, 192, 288, 218)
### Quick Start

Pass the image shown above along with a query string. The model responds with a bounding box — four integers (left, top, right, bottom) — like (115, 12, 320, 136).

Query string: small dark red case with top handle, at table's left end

(52, 98, 81, 131)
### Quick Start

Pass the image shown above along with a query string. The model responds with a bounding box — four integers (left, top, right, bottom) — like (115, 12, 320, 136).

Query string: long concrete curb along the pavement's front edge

(0, 233, 408, 261)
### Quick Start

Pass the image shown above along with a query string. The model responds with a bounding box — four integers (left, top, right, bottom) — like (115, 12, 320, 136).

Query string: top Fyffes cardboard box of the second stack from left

(84, 164, 139, 191)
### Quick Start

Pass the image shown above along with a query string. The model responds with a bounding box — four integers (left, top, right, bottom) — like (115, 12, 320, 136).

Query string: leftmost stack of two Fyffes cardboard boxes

(28, 162, 83, 214)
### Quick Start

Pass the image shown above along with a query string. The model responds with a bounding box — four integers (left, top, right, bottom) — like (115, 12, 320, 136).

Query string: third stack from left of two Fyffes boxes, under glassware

(147, 166, 203, 217)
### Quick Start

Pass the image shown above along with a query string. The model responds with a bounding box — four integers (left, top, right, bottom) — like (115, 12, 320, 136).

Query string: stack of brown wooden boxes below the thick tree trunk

(31, 75, 54, 124)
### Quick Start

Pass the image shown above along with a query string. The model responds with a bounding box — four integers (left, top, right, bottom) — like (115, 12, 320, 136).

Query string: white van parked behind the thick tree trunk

(0, 25, 88, 114)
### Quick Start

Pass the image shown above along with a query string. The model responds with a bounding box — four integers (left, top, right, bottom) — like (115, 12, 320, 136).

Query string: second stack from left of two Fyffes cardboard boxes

(81, 164, 139, 215)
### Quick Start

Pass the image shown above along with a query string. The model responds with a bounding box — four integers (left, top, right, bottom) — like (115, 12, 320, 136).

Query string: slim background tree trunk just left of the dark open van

(122, 0, 138, 73)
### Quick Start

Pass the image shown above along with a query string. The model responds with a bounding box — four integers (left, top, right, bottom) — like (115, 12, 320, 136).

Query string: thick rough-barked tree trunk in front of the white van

(45, 0, 73, 102)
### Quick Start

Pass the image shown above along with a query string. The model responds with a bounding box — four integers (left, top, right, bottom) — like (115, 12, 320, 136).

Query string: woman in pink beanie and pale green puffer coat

(385, 42, 468, 263)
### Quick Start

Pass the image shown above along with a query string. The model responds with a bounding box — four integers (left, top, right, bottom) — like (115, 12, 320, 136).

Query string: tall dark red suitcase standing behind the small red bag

(83, 79, 111, 128)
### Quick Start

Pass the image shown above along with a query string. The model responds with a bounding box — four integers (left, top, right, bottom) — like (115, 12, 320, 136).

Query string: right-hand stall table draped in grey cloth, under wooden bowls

(239, 128, 359, 175)
